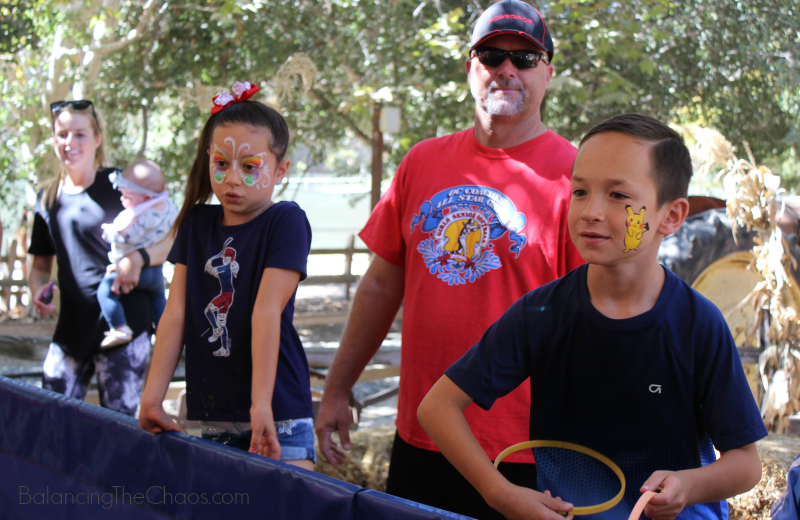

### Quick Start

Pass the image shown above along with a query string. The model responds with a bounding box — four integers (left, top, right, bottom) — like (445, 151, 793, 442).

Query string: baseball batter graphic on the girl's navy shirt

(204, 238, 239, 357)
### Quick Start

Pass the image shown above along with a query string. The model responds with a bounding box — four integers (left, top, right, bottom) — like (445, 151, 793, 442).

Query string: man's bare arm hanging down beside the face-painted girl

(314, 256, 405, 467)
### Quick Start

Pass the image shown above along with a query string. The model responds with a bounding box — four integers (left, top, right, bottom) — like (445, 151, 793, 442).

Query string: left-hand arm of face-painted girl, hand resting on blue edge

(139, 264, 186, 433)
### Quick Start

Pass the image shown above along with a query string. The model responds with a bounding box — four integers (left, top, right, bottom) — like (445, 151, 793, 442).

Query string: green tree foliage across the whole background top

(0, 0, 800, 217)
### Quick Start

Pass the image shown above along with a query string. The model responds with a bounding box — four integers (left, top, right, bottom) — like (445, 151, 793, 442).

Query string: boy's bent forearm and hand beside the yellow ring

(417, 375, 572, 520)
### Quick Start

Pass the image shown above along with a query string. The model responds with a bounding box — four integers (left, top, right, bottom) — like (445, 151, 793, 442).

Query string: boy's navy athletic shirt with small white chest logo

(446, 265, 767, 519)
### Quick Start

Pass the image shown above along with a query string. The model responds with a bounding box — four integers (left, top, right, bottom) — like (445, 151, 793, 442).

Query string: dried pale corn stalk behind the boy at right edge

(715, 141, 800, 433)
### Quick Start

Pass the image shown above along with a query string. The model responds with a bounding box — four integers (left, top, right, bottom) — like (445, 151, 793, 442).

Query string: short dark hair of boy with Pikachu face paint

(580, 114, 692, 207)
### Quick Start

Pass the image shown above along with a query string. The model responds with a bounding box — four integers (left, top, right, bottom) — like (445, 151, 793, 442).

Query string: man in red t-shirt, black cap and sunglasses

(316, 0, 583, 518)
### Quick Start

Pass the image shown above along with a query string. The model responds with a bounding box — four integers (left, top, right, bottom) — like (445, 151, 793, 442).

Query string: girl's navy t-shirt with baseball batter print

(168, 202, 314, 422)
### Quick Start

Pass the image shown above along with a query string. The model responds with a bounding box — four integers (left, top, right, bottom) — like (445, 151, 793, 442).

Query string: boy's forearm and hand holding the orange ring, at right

(641, 443, 761, 520)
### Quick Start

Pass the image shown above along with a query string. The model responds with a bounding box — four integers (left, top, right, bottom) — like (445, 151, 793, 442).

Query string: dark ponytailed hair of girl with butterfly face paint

(172, 100, 289, 234)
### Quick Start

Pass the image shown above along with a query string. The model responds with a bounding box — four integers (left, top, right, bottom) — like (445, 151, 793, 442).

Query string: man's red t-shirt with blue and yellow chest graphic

(359, 129, 583, 462)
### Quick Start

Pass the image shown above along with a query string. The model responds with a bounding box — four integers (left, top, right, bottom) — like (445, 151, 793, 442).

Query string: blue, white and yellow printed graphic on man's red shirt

(411, 185, 527, 285)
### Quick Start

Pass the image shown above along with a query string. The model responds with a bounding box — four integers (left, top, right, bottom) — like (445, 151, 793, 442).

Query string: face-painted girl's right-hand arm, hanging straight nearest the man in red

(250, 267, 300, 459)
